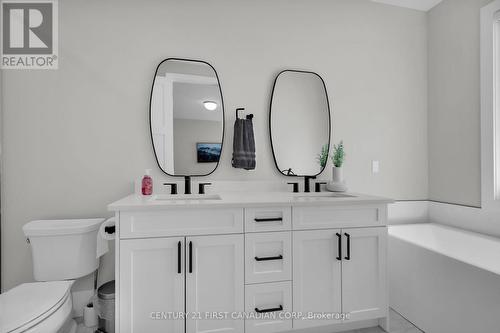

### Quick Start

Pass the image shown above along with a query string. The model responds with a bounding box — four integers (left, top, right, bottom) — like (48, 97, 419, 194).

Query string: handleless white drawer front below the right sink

(293, 205, 387, 230)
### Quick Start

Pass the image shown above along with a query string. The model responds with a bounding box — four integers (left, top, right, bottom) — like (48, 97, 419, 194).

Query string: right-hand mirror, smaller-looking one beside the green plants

(270, 70, 330, 176)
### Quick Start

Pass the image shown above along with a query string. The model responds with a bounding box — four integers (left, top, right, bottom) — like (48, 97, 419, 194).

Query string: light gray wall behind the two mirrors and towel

(1, 0, 428, 290)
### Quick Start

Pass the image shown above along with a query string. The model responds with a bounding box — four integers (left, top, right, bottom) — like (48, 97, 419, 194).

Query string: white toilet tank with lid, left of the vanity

(23, 219, 104, 281)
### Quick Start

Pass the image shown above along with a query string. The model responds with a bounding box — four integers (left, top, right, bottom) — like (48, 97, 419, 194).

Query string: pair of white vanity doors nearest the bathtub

(293, 227, 388, 328)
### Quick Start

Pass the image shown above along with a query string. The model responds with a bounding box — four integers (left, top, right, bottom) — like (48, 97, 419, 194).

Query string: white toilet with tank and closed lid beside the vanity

(0, 219, 104, 333)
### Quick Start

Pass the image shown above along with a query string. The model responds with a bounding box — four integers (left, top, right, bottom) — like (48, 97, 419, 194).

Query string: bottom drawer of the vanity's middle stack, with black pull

(245, 281, 292, 333)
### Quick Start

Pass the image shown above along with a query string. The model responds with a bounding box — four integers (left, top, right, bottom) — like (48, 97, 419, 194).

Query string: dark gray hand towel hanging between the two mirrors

(232, 119, 255, 170)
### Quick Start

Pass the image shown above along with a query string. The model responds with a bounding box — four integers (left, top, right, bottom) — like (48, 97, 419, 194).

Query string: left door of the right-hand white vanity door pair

(293, 229, 342, 329)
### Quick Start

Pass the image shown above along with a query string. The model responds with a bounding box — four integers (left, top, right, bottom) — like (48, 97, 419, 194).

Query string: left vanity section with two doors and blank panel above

(116, 208, 245, 333)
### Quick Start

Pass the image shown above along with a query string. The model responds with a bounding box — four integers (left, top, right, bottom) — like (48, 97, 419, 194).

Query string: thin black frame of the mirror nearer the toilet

(149, 58, 226, 178)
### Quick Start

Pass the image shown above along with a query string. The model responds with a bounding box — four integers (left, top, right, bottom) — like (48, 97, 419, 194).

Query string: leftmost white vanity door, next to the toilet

(119, 237, 185, 333)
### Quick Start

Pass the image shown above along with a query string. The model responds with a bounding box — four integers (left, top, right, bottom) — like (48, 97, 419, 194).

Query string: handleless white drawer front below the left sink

(119, 208, 243, 238)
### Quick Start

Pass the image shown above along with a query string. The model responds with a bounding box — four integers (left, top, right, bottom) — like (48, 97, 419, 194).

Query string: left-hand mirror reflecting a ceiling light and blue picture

(150, 59, 224, 176)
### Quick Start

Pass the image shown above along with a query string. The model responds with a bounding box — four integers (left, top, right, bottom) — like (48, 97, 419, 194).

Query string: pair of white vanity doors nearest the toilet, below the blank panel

(119, 235, 244, 333)
